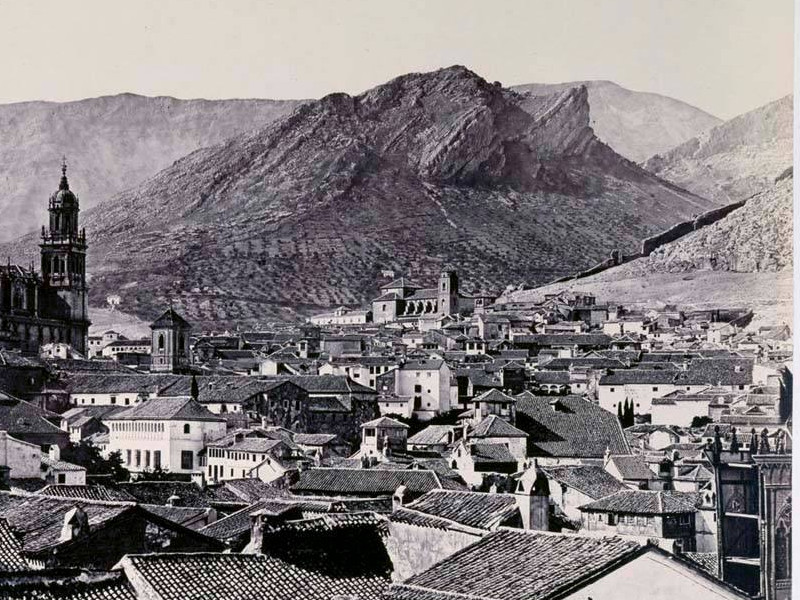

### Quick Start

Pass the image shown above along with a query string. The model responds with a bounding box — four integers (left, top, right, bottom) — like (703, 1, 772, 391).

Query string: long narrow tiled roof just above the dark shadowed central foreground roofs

(291, 468, 442, 495)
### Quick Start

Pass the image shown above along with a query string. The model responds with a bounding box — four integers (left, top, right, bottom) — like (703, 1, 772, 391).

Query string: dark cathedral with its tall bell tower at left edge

(0, 163, 89, 354)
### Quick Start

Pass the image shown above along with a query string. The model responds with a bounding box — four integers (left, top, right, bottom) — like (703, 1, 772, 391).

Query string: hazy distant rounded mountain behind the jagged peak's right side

(512, 81, 722, 162)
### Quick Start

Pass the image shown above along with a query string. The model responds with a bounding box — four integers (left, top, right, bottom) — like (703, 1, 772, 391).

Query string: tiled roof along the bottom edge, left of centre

(120, 554, 389, 600)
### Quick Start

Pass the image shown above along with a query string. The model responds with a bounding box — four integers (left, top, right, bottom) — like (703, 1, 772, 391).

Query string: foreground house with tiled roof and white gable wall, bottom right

(385, 528, 747, 600)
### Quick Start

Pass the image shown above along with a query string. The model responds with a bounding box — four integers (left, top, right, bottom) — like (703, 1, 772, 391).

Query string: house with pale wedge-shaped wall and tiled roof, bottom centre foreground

(386, 490, 522, 581)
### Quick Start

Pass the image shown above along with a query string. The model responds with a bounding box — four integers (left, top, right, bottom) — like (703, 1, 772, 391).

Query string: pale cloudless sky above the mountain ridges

(0, 0, 793, 119)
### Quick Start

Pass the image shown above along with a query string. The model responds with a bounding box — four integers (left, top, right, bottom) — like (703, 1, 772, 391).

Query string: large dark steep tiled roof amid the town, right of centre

(516, 392, 630, 458)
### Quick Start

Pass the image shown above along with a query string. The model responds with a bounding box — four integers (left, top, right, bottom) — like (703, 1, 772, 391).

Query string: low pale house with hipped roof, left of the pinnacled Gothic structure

(580, 490, 697, 553)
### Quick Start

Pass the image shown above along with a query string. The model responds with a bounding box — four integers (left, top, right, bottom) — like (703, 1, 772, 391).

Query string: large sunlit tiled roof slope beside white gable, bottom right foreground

(387, 529, 643, 600)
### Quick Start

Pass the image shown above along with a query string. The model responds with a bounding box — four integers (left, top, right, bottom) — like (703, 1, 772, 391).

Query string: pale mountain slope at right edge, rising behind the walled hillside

(644, 95, 793, 204)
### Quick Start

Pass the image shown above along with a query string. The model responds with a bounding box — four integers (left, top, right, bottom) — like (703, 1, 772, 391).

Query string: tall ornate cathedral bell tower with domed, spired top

(39, 160, 90, 354)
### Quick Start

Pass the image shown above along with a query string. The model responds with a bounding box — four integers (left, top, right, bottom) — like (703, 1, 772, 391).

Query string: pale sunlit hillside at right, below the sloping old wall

(508, 172, 793, 324)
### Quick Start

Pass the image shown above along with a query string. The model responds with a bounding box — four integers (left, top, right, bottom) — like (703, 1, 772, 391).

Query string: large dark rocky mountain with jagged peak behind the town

(0, 67, 713, 327)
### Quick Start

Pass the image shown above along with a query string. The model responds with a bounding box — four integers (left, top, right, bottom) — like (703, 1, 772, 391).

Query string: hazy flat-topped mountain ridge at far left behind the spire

(0, 94, 298, 241)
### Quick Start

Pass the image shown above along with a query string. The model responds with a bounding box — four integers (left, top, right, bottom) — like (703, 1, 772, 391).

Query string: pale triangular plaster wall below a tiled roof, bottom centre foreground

(386, 521, 480, 581)
